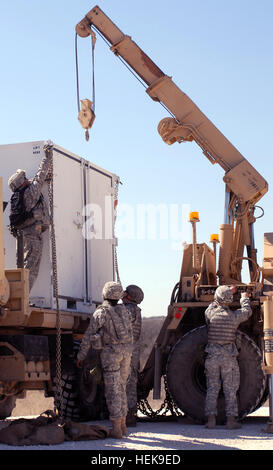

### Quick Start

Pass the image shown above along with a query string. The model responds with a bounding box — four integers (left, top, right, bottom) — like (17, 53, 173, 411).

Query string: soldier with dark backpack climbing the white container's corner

(8, 141, 53, 290)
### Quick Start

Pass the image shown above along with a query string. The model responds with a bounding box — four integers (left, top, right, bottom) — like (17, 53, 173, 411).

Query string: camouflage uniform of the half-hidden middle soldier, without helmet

(122, 302, 142, 408)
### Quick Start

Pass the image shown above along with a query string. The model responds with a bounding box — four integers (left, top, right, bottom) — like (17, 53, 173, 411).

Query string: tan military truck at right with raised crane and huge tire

(76, 6, 273, 422)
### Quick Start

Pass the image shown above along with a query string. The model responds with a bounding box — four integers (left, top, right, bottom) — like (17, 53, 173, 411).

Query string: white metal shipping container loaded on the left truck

(0, 141, 119, 313)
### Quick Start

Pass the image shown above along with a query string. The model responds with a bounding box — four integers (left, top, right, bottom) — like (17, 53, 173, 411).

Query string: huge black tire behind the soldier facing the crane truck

(166, 326, 266, 424)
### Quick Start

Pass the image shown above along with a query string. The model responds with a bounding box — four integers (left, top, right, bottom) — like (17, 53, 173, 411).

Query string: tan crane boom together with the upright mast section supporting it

(76, 6, 268, 281)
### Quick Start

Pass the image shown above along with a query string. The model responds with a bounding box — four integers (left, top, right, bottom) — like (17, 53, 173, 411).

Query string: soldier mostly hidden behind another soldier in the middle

(122, 285, 144, 426)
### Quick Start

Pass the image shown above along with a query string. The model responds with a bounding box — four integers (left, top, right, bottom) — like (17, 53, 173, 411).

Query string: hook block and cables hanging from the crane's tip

(75, 29, 96, 141)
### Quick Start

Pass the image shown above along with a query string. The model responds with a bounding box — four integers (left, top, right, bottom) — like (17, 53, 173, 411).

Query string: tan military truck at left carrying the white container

(0, 141, 119, 419)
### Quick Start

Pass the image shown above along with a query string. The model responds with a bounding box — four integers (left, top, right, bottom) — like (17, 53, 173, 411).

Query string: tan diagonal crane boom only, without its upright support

(76, 6, 268, 207)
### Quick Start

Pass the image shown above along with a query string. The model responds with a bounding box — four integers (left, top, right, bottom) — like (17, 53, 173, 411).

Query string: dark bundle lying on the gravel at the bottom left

(0, 410, 110, 446)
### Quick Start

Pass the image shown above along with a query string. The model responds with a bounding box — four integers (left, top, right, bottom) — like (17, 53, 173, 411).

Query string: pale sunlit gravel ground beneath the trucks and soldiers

(0, 396, 273, 452)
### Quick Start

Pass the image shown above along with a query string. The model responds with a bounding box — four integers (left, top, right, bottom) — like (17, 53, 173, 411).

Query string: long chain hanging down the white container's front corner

(44, 143, 63, 419)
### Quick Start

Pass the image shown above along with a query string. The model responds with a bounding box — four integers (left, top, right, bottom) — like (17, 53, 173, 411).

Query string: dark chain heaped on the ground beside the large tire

(137, 375, 183, 419)
